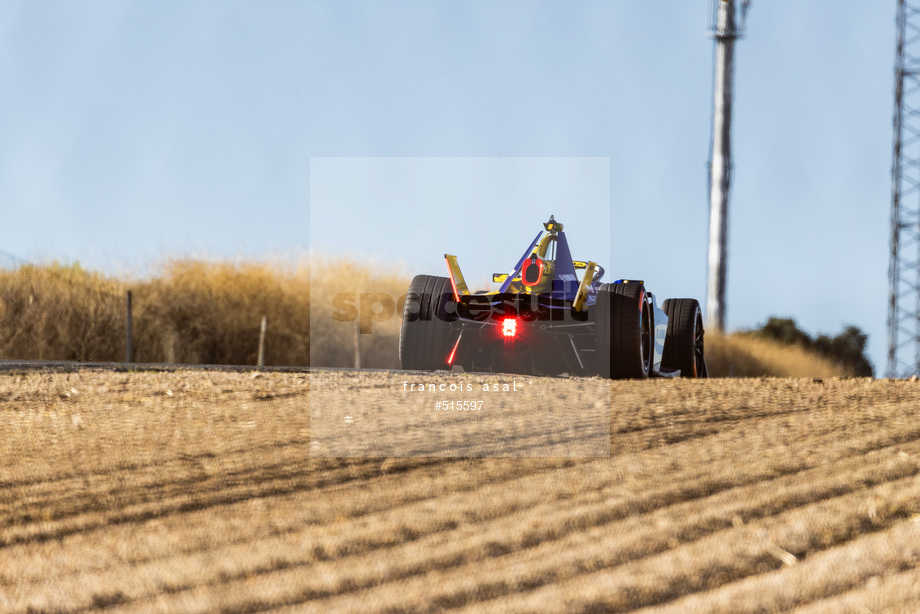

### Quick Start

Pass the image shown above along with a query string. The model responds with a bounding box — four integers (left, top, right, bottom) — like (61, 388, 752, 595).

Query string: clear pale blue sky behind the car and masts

(0, 0, 896, 373)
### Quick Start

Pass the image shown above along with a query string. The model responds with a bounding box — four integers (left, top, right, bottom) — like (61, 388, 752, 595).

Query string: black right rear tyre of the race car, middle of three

(594, 282, 654, 379)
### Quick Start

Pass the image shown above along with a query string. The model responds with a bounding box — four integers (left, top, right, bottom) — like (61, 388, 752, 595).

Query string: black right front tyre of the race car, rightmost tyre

(661, 298, 709, 377)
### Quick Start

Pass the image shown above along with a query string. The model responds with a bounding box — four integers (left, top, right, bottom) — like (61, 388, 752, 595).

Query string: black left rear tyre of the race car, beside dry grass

(399, 275, 457, 371)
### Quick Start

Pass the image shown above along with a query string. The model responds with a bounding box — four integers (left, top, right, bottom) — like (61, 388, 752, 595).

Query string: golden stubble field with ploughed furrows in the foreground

(0, 371, 920, 613)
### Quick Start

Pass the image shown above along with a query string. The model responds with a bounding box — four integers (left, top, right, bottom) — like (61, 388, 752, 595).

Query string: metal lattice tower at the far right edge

(888, 0, 920, 377)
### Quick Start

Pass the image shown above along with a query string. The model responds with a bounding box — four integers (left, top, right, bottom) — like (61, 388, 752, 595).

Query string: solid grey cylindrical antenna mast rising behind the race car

(706, 0, 750, 331)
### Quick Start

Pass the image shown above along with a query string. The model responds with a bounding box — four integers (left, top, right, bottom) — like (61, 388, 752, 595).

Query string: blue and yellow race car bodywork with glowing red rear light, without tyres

(426, 216, 679, 377)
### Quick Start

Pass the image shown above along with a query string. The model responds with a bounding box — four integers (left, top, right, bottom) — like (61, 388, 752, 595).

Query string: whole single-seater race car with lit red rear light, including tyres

(399, 216, 708, 379)
